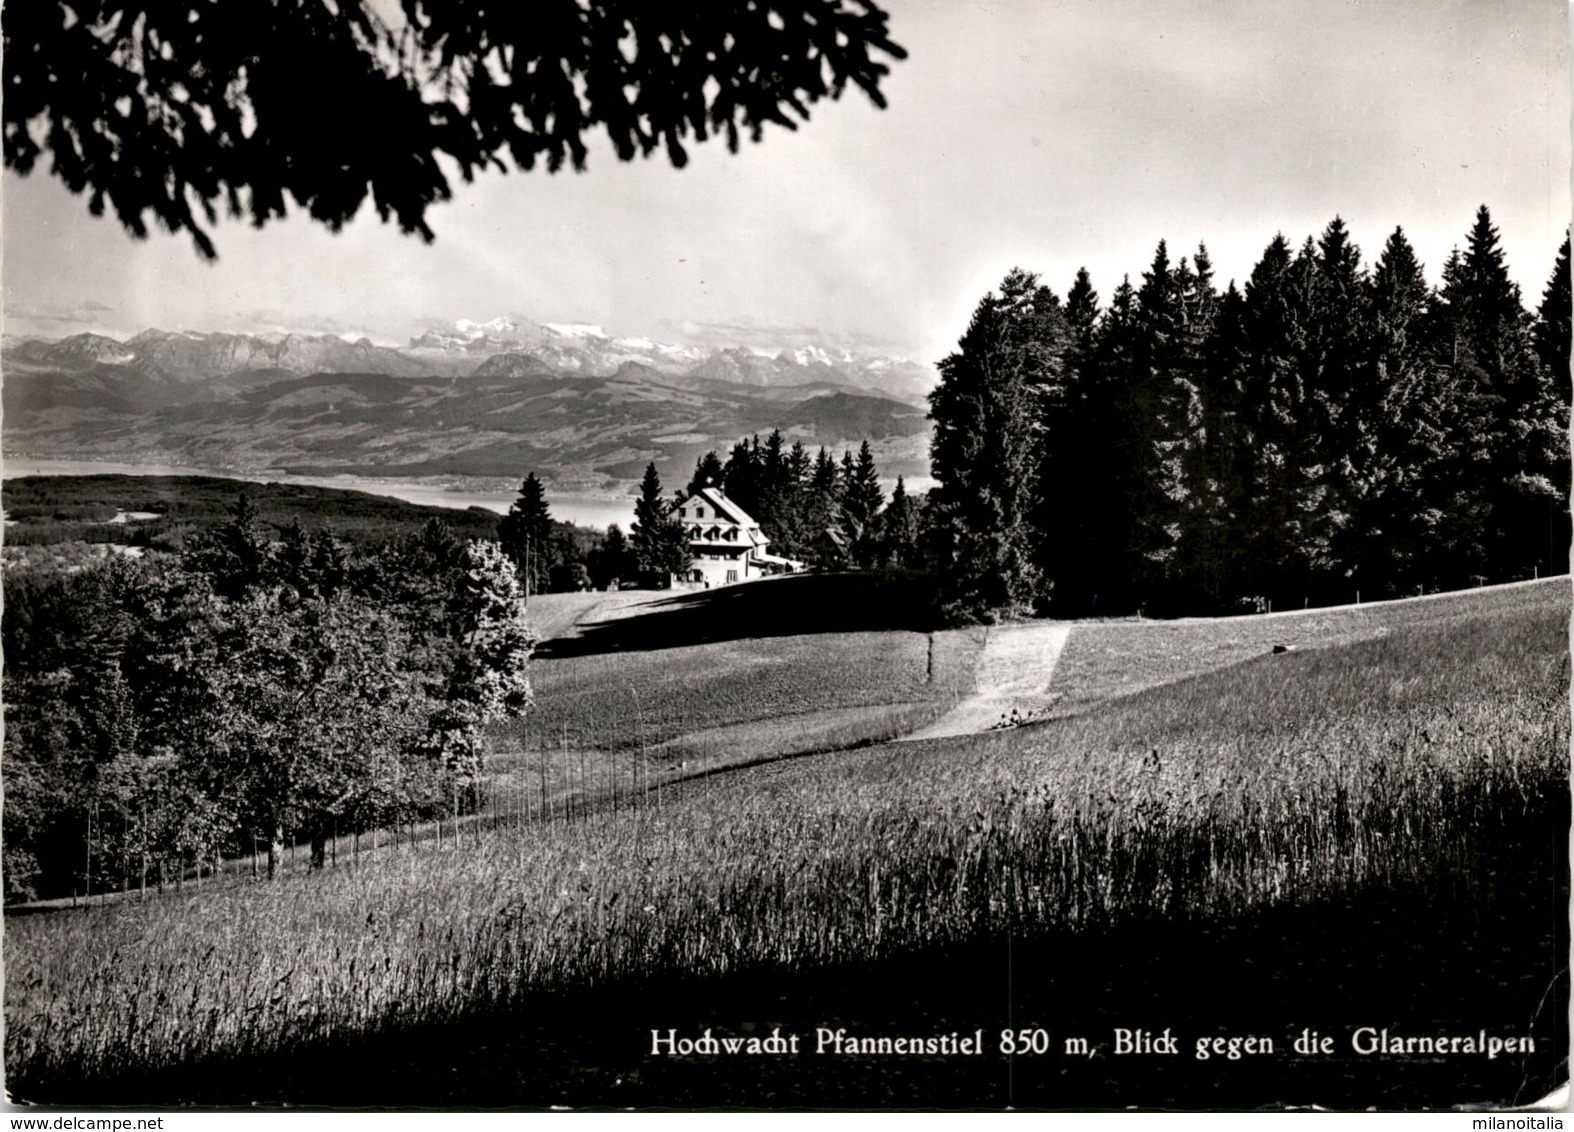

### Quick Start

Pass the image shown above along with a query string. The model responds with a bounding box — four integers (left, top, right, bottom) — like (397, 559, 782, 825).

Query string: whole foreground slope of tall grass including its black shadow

(5, 583, 1569, 1107)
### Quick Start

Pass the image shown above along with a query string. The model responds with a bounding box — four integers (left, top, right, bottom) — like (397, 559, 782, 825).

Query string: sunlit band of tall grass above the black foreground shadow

(5, 600, 1569, 1097)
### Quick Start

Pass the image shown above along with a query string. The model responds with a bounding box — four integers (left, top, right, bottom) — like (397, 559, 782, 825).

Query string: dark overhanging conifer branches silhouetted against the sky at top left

(0, 0, 907, 260)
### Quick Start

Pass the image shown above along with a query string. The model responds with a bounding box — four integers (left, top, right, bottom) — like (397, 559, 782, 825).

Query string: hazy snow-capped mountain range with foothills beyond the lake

(0, 320, 929, 493)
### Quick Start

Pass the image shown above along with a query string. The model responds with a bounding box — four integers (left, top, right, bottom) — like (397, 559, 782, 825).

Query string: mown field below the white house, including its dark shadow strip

(486, 576, 984, 819)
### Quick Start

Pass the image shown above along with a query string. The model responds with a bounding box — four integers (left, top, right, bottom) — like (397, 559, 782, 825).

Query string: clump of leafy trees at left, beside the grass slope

(0, 496, 534, 902)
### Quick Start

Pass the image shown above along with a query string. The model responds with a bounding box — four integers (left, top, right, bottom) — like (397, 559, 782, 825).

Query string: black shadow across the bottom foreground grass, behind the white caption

(30, 806, 1569, 1110)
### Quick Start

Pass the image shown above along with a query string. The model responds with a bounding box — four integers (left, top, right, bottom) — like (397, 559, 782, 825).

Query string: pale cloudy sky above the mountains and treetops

(0, 0, 1571, 362)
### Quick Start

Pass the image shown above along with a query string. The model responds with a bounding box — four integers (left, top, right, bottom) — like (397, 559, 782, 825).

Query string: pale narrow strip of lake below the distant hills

(0, 455, 634, 531)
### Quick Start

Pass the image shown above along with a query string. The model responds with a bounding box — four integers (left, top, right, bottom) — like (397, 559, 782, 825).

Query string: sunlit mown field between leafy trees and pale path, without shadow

(488, 630, 982, 817)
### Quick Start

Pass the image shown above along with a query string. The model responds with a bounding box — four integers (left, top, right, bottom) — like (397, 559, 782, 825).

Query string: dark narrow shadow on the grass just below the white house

(535, 572, 937, 658)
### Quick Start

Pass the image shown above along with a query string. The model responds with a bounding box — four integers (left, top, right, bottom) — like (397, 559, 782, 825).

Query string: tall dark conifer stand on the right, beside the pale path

(930, 206, 1569, 619)
